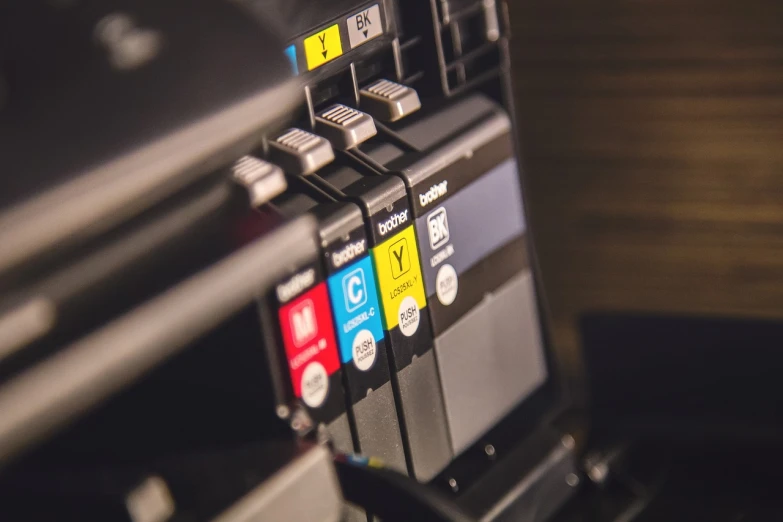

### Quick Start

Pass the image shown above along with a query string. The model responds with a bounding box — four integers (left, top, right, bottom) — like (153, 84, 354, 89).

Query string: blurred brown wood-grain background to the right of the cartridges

(509, 0, 783, 404)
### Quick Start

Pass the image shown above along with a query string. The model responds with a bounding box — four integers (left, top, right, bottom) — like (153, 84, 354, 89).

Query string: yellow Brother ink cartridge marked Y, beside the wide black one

(308, 164, 452, 481)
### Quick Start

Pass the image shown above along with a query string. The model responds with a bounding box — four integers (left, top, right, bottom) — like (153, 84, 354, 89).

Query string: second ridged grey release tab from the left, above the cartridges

(269, 129, 334, 175)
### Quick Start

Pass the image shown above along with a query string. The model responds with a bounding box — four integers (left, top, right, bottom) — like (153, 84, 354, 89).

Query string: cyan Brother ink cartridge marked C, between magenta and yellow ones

(273, 182, 406, 472)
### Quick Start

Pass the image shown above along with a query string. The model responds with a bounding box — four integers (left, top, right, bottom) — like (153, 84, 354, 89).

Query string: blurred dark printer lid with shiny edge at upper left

(0, 0, 301, 280)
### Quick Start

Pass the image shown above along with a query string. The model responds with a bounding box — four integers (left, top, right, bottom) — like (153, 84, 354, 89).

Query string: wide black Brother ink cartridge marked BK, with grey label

(363, 95, 546, 453)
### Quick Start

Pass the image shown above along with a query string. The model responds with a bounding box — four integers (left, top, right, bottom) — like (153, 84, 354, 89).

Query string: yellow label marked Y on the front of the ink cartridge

(372, 225, 427, 330)
